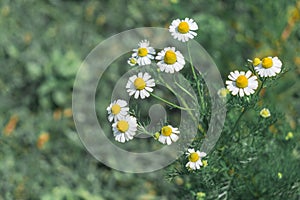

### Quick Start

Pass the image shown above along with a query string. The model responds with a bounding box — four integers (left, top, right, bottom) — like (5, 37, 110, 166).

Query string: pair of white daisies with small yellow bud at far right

(226, 57, 282, 97)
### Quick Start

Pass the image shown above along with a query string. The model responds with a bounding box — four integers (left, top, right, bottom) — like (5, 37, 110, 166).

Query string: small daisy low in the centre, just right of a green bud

(158, 125, 179, 145)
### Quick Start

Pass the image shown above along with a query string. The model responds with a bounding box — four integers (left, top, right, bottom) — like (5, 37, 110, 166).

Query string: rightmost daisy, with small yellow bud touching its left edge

(253, 57, 282, 77)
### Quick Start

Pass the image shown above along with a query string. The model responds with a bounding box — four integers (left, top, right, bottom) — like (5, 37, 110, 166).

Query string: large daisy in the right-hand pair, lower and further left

(226, 71, 258, 97)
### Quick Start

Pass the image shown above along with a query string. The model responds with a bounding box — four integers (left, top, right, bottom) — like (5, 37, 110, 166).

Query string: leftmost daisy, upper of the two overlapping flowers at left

(106, 99, 129, 122)
